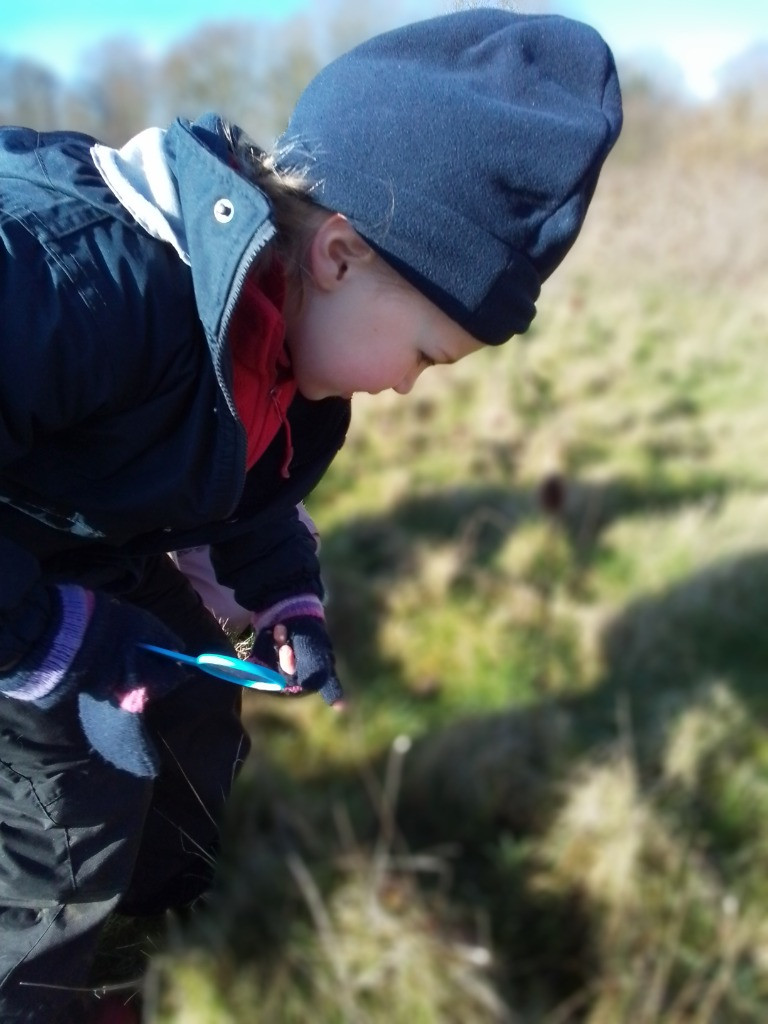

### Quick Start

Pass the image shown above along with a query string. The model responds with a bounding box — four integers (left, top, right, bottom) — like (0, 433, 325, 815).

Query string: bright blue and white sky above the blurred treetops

(0, 0, 768, 96)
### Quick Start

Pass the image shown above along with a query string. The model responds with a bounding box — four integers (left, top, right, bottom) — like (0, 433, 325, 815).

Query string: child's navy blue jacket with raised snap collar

(0, 118, 349, 660)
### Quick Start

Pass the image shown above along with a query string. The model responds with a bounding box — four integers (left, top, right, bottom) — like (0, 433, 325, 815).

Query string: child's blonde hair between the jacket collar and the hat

(225, 125, 333, 299)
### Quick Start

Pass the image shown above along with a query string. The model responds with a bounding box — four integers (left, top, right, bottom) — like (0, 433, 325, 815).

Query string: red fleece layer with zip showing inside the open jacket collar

(229, 264, 296, 476)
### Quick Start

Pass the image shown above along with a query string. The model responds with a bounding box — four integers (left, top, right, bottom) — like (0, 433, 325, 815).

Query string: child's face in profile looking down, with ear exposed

(286, 214, 484, 400)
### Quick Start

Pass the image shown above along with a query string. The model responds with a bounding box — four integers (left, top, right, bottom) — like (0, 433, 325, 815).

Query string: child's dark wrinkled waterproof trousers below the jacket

(0, 556, 249, 1024)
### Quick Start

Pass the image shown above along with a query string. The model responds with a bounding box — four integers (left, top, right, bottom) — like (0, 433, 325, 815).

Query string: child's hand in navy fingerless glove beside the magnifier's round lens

(251, 615, 345, 711)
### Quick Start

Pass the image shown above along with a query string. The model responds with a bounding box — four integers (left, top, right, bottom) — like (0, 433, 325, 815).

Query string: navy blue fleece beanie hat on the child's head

(279, 8, 622, 345)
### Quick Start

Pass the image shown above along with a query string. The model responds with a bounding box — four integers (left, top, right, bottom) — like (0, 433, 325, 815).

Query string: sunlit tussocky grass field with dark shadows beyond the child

(100, 103, 768, 1024)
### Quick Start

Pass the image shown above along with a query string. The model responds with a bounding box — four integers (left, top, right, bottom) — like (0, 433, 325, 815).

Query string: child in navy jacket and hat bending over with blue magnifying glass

(0, 9, 621, 1024)
